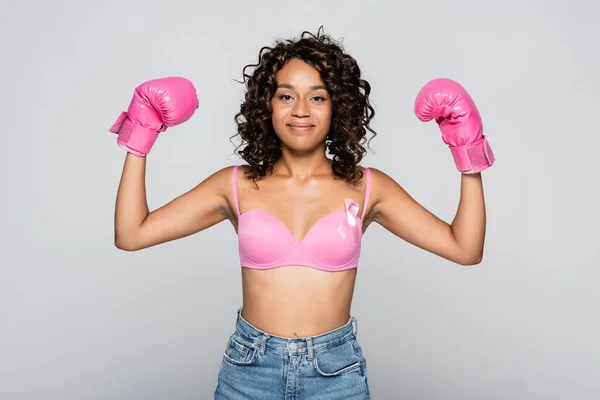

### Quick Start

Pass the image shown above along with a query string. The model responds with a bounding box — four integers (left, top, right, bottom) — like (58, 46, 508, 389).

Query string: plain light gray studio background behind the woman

(0, 0, 600, 400)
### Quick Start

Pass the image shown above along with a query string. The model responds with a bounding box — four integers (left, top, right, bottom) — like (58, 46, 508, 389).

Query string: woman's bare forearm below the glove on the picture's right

(451, 173, 486, 264)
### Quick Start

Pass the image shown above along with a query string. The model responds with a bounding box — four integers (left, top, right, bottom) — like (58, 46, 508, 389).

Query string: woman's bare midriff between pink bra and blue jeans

(242, 266, 356, 338)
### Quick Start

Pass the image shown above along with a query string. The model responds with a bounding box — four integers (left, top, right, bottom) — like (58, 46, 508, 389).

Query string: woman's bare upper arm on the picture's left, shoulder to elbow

(120, 167, 233, 250)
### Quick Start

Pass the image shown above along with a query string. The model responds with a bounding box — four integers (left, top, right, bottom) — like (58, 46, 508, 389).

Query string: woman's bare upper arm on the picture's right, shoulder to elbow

(371, 168, 465, 264)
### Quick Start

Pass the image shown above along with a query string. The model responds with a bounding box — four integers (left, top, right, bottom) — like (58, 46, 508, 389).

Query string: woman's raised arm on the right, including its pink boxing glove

(372, 79, 495, 265)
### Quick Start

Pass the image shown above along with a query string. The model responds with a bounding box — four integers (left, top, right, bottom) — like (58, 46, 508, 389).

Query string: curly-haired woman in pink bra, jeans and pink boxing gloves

(111, 28, 494, 400)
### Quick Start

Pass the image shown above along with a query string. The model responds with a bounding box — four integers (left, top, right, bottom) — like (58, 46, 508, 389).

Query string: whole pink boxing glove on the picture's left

(109, 77, 199, 157)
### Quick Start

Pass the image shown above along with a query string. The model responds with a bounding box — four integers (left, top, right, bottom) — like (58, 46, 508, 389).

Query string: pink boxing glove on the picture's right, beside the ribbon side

(415, 78, 495, 174)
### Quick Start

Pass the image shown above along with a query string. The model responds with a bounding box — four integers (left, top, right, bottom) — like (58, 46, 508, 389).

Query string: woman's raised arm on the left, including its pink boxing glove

(109, 77, 230, 251)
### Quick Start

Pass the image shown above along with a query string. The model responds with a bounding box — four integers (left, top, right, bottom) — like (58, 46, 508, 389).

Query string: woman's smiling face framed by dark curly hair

(271, 59, 333, 152)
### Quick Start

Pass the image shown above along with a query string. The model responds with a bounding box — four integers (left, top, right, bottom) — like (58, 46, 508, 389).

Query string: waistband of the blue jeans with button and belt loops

(235, 308, 357, 358)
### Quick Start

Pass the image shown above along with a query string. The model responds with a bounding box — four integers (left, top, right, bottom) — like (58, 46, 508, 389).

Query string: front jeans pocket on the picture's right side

(313, 341, 363, 377)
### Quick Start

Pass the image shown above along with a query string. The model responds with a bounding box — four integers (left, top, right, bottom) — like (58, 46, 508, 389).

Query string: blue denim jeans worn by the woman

(214, 309, 370, 400)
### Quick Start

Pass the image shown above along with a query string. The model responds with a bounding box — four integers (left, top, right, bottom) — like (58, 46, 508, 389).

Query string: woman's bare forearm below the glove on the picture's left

(115, 153, 149, 247)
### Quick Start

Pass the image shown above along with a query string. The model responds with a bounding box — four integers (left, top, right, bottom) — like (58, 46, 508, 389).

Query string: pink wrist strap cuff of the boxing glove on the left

(109, 111, 159, 157)
